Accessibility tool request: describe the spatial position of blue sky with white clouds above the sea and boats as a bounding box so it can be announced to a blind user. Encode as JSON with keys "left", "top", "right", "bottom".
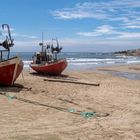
{"left": 0, "top": 0, "right": 140, "bottom": 52}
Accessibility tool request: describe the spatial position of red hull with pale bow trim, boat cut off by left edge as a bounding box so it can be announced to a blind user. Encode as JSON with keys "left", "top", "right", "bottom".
{"left": 0, "top": 57, "right": 23, "bottom": 86}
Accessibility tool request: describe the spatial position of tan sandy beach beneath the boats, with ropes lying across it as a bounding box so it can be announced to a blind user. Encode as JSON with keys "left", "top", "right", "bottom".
{"left": 0, "top": 65, "right": 140, "bottom": 140}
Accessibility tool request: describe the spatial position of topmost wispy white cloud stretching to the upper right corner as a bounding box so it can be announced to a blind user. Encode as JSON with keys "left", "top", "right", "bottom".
{"left": 52, "top": 0, "right": 140, "bottom": 22}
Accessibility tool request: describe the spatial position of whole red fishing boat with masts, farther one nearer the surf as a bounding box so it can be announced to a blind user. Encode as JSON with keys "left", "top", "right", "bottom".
{"left": 30, "top": 34, "right": 67, "bottom": 75}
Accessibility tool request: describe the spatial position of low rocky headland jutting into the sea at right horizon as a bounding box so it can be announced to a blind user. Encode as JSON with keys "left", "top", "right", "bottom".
{"left": 114, "top": 49, "right": 140, "bottom": 56}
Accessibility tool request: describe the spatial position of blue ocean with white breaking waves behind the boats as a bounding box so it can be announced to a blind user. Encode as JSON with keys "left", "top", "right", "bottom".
{"left": 10, "top": 52, "right": 140, "bottom": 70}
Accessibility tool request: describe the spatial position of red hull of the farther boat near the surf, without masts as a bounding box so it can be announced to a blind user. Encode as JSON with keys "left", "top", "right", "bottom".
{"left": 30, "top": 59, "right": 67, "bottom": 75}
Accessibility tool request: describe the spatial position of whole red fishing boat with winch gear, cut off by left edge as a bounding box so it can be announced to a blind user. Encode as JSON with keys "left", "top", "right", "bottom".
{"left": 0, "top": 24, "right": 23, "bottom": 86}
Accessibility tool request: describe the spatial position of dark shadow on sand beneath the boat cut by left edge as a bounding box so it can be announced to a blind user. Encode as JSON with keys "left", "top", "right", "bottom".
{"left": 0, "top": 84, "right": 24, "bottom": 93}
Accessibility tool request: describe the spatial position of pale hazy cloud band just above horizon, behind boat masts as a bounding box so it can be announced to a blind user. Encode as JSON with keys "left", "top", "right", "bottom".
{"left": 12, "top": 35, "right": 140, "bottom": 52}
